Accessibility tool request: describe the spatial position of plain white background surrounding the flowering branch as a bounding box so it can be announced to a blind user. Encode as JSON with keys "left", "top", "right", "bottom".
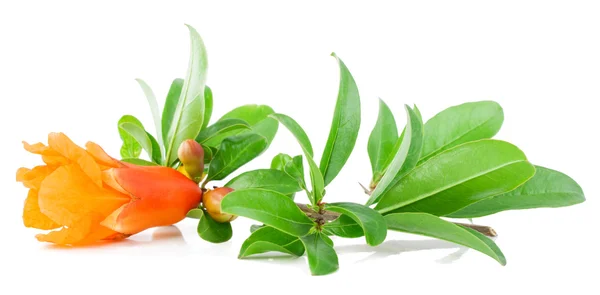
{"left": 0, "top": 0, "right": 600, "bottom": 294}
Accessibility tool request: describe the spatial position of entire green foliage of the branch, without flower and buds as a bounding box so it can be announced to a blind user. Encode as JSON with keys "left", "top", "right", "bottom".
{"left": 119, "top": 27, "right": 585, "bottom": 275}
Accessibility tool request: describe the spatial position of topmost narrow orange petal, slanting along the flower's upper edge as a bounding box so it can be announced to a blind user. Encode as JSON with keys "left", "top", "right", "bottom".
{"left": 48, "top": 133, "right": 102, "bottom": 186}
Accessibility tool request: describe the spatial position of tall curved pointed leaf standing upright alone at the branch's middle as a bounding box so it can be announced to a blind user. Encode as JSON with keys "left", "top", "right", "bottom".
{"left": 319, "top": 53, "right": 360, "bottom": 186}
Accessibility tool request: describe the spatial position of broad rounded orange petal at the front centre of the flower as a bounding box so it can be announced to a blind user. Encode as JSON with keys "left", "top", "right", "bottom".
{"left": 38, "top": 164, "right": 131, "bottom": 227}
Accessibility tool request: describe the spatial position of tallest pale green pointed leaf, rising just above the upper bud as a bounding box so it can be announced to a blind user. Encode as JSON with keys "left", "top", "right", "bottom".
{"left": 166, "top": 25, "right": 208, "bottom": 166}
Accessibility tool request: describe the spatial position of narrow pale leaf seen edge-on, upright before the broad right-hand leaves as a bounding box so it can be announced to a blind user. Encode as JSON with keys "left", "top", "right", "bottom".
{"left": 367, "top": 105, "right": 423, "bottom": 205}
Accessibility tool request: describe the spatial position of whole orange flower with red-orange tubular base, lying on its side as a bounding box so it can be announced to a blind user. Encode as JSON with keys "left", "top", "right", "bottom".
{"left": 17, "top": 133, "right": 202, "bottom": 245}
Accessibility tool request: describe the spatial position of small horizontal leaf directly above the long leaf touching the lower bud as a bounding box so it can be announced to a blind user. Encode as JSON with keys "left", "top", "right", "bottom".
{"left": 225, "top": 169, "right": 302, "bottom": 195}
